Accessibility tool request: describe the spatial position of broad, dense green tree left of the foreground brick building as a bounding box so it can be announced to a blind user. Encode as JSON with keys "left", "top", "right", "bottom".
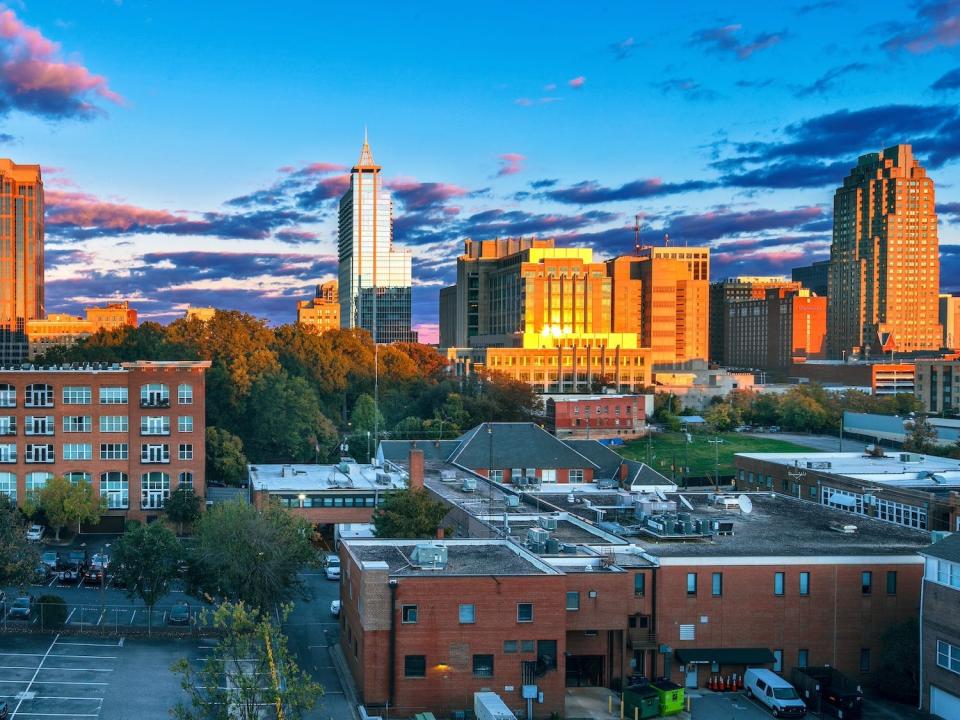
{"left": 191, "top": 501, "right": 316, "bottom": 610}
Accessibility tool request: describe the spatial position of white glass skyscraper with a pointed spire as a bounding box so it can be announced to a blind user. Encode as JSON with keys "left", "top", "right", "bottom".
{"left": 338, "top": 136, "right": 416, "bottom": 343}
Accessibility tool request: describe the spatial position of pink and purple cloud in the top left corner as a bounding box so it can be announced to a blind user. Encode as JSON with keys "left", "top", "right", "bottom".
{"left": 0, "top": 6, "right": 124, "bottom": 120}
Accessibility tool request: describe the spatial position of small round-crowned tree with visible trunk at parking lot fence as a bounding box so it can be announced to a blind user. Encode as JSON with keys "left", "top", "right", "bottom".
{"left": 110, "top": 522, "right": 181, "bottom": 632}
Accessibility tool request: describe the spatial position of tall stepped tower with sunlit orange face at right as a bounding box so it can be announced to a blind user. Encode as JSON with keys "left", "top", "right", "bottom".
{"left": 828, "top": 145, "right": 943, "bottom": 357}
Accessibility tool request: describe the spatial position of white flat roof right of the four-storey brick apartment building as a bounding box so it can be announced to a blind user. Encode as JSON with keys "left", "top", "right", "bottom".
{"left": 247, "top": 462, "right": 407, "bottom": 493}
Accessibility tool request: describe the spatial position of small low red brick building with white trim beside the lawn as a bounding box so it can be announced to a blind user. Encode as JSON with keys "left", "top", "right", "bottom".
{"left": 546, "top": 395, "right": 653, "bottom": 440}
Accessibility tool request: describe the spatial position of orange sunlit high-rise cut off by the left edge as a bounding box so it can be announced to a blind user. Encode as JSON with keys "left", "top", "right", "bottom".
{"left": 0, "top": 158, "right": 45, "bottom": 365}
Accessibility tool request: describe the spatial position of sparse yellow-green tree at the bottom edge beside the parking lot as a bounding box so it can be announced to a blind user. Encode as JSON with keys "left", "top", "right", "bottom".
{"left": 172, "top": 603, "right": 323, "bottom": 720}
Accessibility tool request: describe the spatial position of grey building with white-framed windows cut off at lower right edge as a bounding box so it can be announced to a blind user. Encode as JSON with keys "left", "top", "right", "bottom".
{"left": 920, "top": 534, "right": 960, "bottom": 720}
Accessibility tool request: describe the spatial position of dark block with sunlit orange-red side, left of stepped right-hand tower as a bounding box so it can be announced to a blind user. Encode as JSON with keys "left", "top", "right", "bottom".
{"left": 723, "top": 288, "right": 827, "bottom": 379}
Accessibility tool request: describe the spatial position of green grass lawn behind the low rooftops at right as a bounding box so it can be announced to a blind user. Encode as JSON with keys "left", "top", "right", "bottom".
{"left": 615, "top": 432, "right": 810, "bottom": 480}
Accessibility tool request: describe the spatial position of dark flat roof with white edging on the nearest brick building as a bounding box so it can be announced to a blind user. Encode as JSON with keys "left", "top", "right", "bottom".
{"left": 343, "top": 539, "right": 560, "bottom": 577}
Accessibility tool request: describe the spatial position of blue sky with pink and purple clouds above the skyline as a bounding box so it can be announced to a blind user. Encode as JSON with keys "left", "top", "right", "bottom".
{"left": 0, "top": 0, "right": 960, "bottom": 341}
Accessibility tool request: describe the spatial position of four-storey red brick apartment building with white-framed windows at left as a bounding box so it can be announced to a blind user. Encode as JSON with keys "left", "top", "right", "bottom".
{"left": 0, "top": 361, "right": 210, "bottom": 532}
